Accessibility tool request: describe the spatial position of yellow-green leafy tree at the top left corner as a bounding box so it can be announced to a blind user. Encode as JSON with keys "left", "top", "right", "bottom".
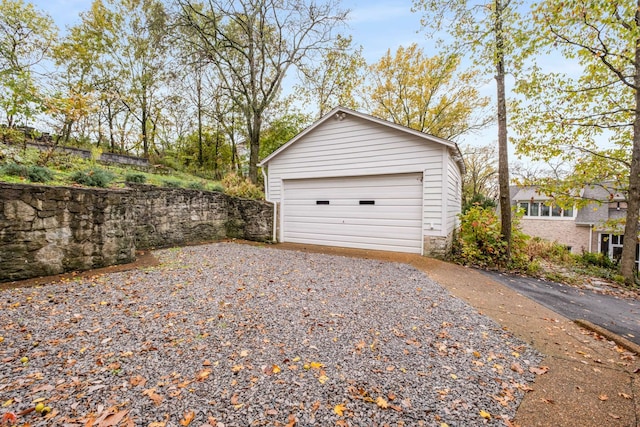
{"left": 0, "top": 0, "right": 58, "bottom": 127}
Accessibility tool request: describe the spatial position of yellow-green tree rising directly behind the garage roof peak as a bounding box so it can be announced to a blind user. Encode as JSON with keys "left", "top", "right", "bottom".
{"left": 296, "top": 35, "right": 367, "bottom": 118}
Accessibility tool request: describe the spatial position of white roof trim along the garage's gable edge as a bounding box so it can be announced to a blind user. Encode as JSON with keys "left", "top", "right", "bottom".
{"left": 258, "top": 106, "right": 465, "bottom": 173}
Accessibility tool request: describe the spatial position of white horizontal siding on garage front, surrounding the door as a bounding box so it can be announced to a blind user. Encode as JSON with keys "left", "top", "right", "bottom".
{"left": 268, "top": 115, "right": 443, "bottom": 234}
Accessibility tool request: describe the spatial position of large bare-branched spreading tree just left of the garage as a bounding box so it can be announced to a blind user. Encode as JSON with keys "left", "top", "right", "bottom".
{"left": 176, "top": 0, "right": 346, "bottom": 183}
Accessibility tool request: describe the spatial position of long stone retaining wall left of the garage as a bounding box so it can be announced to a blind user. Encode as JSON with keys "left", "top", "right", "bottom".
{"left": 0, "top": 183, "right": 273, "bottom": 282}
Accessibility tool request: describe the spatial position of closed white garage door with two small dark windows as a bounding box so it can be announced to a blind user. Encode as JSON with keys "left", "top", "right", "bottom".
{"left": 282, "top": 173, "right": 422, "bottom": 253}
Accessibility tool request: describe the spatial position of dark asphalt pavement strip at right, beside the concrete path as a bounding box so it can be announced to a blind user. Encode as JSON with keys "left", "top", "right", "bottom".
{"left": 480, "top": 270, "right": 640, "bottom": 345}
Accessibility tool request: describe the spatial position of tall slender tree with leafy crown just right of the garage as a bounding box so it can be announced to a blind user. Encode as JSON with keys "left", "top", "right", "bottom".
{"left": 413, "top": 0, "right": 526, "bottom": 259}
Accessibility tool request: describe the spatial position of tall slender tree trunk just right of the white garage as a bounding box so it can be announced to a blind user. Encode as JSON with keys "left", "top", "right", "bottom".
{"left": 495, "top": 0, "right": 511, "bottom": 261}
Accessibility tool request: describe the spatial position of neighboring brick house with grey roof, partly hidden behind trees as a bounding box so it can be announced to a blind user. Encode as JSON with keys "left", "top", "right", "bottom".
{"left": 511, "top": 186, "right": 638, "bottom": 263}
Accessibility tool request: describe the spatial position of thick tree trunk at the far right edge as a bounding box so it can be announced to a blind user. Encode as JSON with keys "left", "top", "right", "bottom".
{"left": 620, "top": 21, "right": 640, "bottom": 285}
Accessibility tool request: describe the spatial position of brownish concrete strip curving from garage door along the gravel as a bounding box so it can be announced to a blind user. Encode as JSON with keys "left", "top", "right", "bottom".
{"left": 275, "top": 243, "right": 640, "bottom": 427}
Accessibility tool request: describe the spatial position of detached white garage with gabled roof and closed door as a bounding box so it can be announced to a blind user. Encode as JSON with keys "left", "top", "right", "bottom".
{"left": 259, "top": 107, "right": 464, "bottom": 255}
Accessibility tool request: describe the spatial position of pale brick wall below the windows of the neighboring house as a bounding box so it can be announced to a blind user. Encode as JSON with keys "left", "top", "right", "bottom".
{"left": 520, "top": 218, "right": 598, "bottom": 254}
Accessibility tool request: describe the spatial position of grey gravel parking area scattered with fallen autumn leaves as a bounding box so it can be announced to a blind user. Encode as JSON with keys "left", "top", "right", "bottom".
{"left": 0, "top": 243, "right": 544, "bottom": 427}
